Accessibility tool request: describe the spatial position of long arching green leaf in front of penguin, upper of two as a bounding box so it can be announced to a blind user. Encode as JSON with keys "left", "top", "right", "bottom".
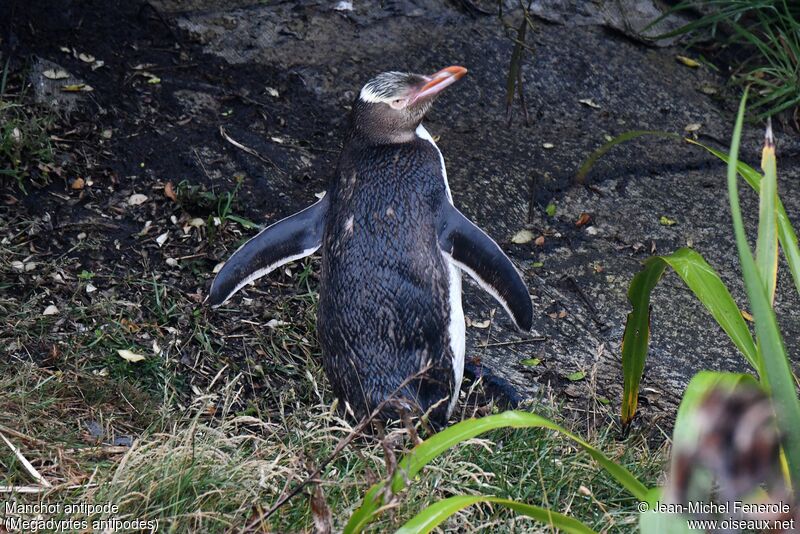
{"left": 344, "top": 410, "right": 648, "bottom": 534}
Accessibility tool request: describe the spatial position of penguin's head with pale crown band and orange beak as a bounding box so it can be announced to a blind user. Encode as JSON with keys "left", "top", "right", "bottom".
{"left": 352, "top": 66, "right": 467, "bottom": 144}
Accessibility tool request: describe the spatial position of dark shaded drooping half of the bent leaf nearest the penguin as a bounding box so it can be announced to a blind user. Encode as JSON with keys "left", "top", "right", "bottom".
{"left": 621, "top": 257, "right": 667, "bottom": 425}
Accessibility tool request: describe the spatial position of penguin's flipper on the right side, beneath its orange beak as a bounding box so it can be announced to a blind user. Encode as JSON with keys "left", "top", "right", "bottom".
{"left": 439, "top": 202, "right": 533, "bottom": 332}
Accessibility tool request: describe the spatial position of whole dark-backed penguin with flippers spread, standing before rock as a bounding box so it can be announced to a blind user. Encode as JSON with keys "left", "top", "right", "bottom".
{"left": 208, "top": 66, "right": 533, "bottom": 428}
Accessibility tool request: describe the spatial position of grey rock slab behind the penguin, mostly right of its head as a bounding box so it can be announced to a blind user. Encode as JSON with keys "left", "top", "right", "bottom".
{"left": 147, "top": 0, "right": 800, "bottom": 426}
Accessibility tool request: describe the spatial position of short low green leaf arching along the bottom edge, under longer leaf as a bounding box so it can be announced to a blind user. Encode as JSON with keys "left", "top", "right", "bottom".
{"left": 396, "top": 495, "right": 595, "bottom": 534}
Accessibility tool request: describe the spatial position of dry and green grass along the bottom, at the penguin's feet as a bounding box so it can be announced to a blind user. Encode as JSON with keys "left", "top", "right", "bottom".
{"left": 0, "top": 354, "right": 665, "bottom": 532}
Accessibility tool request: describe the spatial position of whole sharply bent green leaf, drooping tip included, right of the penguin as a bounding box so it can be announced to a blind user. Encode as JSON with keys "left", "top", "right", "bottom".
{"left": 621, "top": 248, "right": 761, "bottom": 425}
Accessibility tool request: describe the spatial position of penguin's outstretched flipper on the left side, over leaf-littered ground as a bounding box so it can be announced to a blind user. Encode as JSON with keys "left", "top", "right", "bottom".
{"left": 208, "top": 195, "right": 330, "bottom": 308}
